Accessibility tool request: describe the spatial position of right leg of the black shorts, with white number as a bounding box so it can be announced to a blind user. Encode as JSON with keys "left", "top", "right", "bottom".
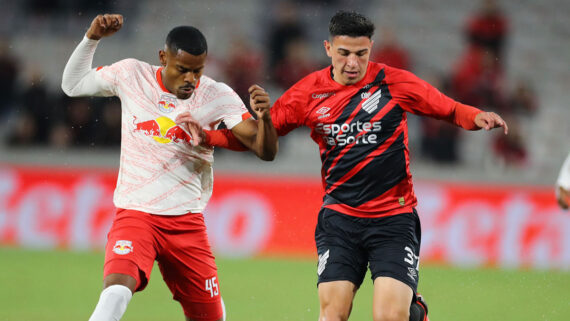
{"left": 363, "top": 211, "right": 421, "bottom": 292}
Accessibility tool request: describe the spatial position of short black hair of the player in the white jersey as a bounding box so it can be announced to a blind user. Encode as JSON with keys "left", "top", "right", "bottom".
{"left": 166, "top": 26, "right": 208, "bottom": 56}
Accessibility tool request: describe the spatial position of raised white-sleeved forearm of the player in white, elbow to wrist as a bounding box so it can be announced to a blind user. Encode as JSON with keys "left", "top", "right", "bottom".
{"left": 61, "top": 37, "right": 98, "bottom": 97}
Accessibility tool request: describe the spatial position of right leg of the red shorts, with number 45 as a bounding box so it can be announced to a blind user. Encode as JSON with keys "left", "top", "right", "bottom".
{"left": 157, "top": 214, "right": 223, "bottom": 320}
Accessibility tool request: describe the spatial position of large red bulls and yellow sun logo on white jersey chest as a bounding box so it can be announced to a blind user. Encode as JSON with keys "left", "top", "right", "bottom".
{"left": 134, "top": 116, "right": 192, "bottom": 144}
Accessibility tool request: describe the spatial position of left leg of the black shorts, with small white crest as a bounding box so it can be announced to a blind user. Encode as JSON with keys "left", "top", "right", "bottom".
{"left": 315, "top": 208, "right": 368, "bottom": 288}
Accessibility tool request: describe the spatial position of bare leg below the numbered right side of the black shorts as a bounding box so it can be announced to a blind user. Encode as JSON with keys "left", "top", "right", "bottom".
{"left": 372, "top": 277, "right": 414, "bottom": 321}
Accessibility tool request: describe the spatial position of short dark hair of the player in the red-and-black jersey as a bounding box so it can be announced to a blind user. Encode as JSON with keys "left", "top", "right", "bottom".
{"left": 329, "top": 10, "right": 375, "bottom": 39}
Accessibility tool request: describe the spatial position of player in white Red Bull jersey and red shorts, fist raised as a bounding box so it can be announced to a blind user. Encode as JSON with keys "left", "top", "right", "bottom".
{"left": 62, "top": 14, "right": 278, "bottom": 321}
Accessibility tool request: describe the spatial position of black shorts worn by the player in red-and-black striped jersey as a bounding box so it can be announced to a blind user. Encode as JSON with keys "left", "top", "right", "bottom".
{"left": 315, "top": 208, "right": 421, "bottom": 293}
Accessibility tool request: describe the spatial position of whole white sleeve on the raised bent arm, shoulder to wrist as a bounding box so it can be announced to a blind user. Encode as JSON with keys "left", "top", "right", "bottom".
{"left": 61, "top": 37, "right": 124, "bottom": 97}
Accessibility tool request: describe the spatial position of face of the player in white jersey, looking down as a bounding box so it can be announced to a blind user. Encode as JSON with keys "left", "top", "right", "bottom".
{"left": 159, "top": 49, "right": 207, "bottom": 99}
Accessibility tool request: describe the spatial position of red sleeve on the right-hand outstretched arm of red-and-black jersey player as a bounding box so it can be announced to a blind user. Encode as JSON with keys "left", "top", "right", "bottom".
{"left": 391, "top": 68, "right": 482, "bottom": 130}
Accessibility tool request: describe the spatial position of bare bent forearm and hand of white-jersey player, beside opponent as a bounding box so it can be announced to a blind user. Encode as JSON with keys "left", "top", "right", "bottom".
{"left": 227, "top": 85, "right": 279, "bottom": 161}
